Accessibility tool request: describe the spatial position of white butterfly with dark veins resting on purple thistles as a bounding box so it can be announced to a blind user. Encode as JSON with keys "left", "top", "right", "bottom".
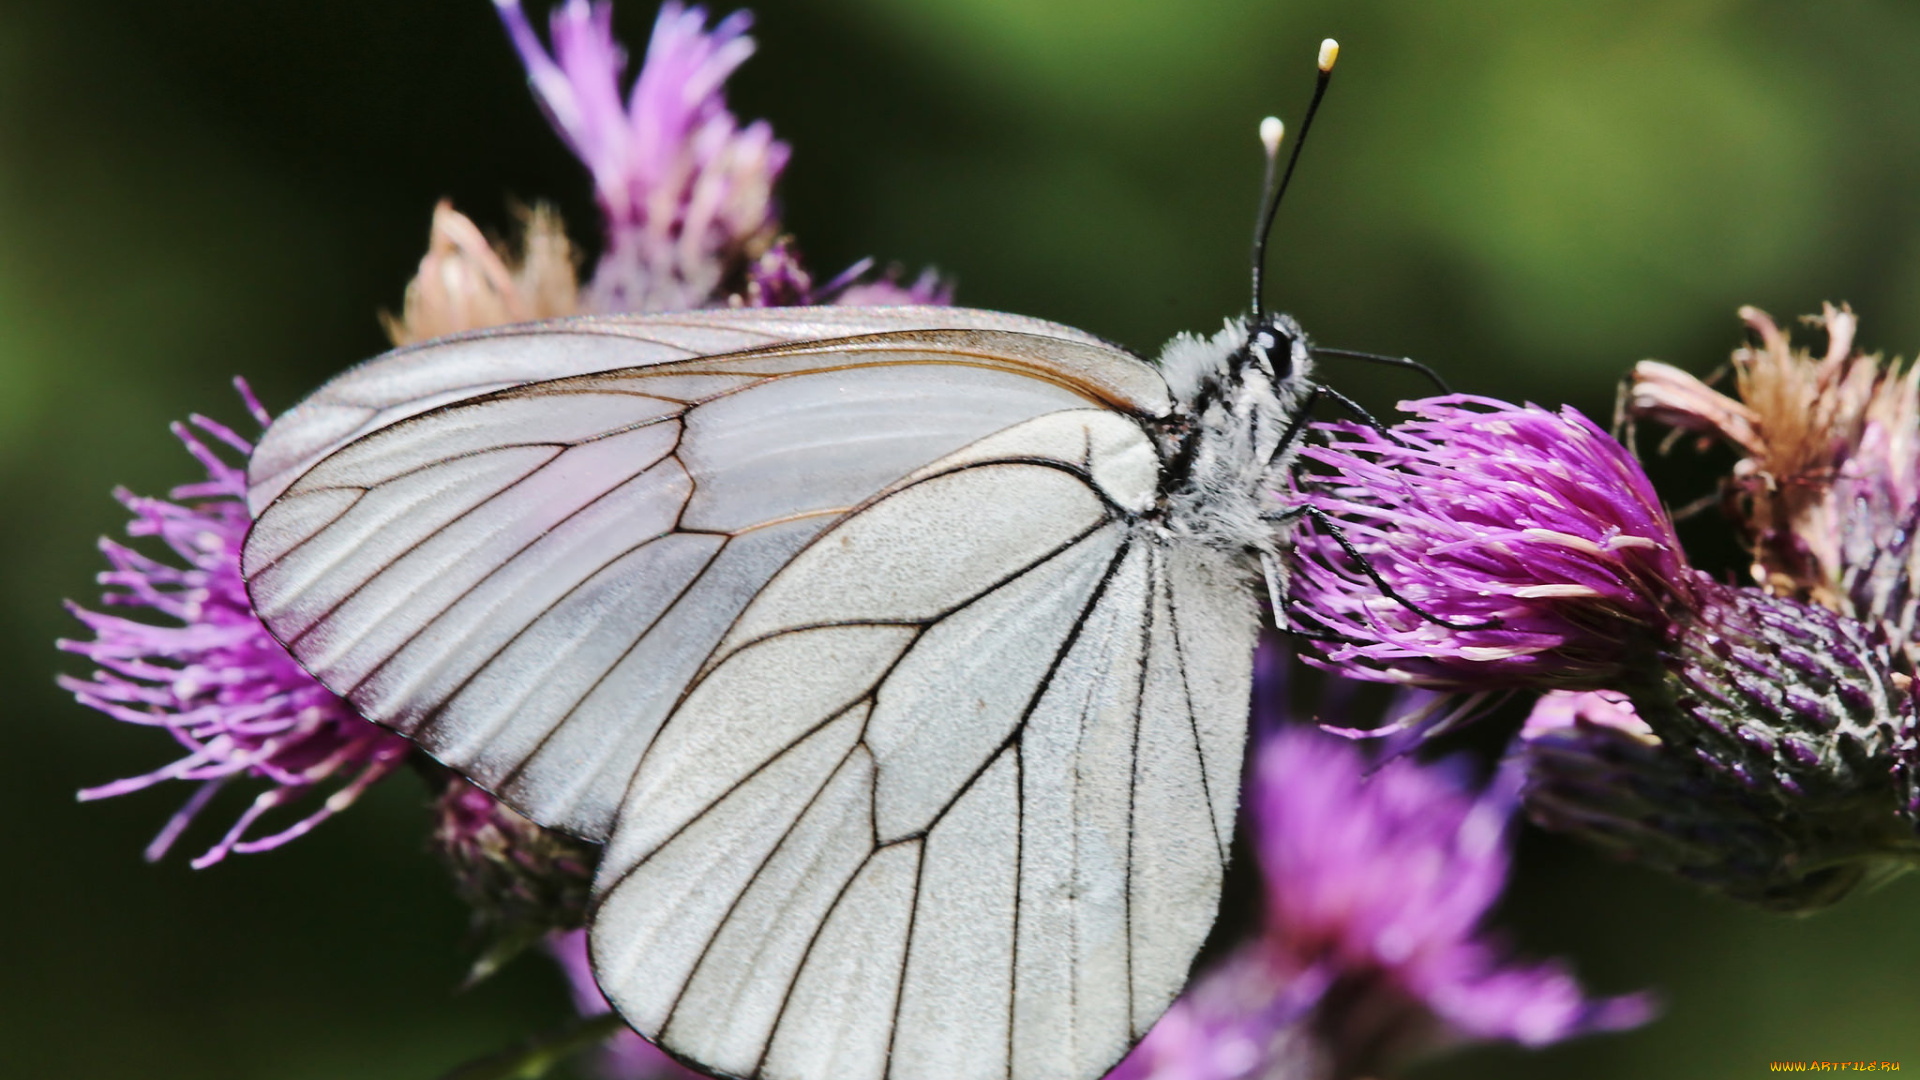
{"left": 244, "top": 37, "right": 1443, "bottom": 1080}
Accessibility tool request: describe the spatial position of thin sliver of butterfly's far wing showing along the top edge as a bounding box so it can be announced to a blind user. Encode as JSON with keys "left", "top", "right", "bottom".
{"left": 248, "top": 306, "right": 1136, "bottom": 515}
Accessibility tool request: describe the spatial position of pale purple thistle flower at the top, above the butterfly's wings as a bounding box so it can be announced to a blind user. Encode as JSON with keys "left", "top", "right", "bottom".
{"left": 495, "top": 0, "right": 789, "bottom": 311}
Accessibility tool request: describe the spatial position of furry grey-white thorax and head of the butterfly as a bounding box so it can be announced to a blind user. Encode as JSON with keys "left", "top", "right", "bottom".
{"left": 1160, "top": 315, "right": 1313, "bottom": 557}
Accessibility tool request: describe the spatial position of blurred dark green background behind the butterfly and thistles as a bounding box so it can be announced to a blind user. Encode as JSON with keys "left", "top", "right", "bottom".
{"left": 11, "top": 0, "right": 1920, "bottom": 1080}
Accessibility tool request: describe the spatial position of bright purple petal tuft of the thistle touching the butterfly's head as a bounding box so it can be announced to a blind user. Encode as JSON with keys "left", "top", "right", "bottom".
{"left": 1292, "top": 394, "right": 1695, "bottom": 688}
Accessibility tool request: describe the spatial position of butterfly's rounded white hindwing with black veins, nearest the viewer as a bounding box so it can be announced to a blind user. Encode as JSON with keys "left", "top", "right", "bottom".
{"left": 593, "top": 409, "right": 1252, "bottom": 1078}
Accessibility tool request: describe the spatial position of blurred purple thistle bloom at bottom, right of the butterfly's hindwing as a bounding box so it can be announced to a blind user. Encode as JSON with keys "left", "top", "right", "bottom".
{"left": 1114, "top": 714, "right": 1651, "bottom": 1080}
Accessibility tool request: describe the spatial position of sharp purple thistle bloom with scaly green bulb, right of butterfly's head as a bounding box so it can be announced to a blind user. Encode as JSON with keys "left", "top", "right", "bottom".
{"left": 1294, "top": 390, "right": 1920, "bottom": 909}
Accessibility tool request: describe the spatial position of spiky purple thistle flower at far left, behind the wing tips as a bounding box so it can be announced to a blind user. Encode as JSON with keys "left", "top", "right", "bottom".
{"left": 60, "top": 380, "right": 411, "bottom": 869}
